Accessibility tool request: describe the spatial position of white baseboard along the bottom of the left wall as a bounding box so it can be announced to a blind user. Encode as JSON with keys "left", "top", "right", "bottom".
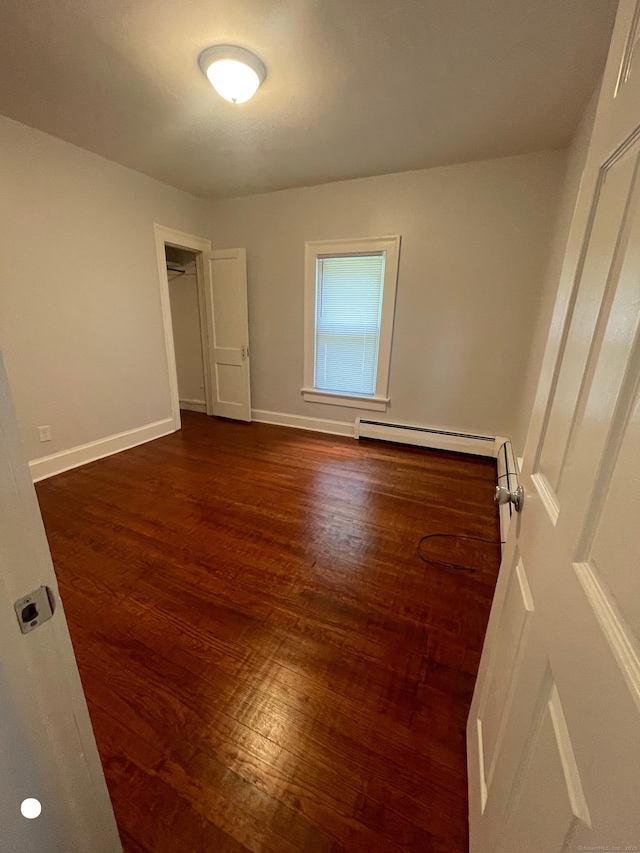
{"left": 29, "top": 418, "right": 175, "bottom": 483}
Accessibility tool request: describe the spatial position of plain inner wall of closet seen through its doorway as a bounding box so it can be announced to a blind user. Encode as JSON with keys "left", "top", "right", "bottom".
{"left": 169, "top": 261, "right": 205, "bottom": 404}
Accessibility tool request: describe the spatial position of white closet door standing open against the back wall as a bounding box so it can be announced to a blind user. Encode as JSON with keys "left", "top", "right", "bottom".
{"left": 205, "top": 249, "right": 251, "bottom": 421}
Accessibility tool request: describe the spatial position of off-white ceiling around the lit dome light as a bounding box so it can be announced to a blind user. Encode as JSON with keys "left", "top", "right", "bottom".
{"left": 0, "top": 0, "right": 615, "bottom": 197}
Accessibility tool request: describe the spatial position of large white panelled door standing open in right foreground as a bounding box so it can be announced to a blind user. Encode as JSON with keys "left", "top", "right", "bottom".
{"left": 467, "top": 0, "right": 640, "bottom": 853}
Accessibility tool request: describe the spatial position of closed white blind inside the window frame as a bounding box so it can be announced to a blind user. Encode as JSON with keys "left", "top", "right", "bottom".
{"left": 314, "top": 252, "right": 386, "bottom": 395}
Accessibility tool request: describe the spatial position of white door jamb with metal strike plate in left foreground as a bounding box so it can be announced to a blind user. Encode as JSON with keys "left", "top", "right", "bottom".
{"left": 0, "top": 350, "right": 122, "bottom": 853}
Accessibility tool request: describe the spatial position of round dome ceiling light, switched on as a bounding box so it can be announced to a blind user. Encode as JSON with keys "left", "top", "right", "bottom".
{"left": 198, "top": 44, "right": 267, "bottom": 104}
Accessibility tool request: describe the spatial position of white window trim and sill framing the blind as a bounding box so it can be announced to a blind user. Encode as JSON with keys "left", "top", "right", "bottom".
{"left": 300, "top": 235, "right": 400, "bottom": 412}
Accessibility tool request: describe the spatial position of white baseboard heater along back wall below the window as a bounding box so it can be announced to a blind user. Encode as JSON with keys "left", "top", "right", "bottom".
{"left": 354, "top": 418, "right": 497, "bottom": 457}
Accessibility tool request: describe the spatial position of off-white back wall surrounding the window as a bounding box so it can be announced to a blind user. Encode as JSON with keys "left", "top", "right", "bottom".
{"left": 209, "top": 152, "right": 564, "bottom": 435}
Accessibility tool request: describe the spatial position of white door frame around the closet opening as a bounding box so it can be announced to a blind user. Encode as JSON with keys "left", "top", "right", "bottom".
{"left": 153, "top": 223, "right": 214, "bottom": 430}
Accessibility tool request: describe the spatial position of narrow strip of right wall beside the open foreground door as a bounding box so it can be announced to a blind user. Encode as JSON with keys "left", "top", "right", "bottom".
{"left": 513, "top": 86, "right": 600, "bottom": 455}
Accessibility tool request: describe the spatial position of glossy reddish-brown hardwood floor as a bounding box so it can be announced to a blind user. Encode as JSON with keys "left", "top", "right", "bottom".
{"left": 37, "top": 412, "right": 499, "bottom": 853}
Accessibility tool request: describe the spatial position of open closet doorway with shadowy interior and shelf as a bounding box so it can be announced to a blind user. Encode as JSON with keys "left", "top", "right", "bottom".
{"left": 165, "top": 244, "right": 207, "bottom": 413}
